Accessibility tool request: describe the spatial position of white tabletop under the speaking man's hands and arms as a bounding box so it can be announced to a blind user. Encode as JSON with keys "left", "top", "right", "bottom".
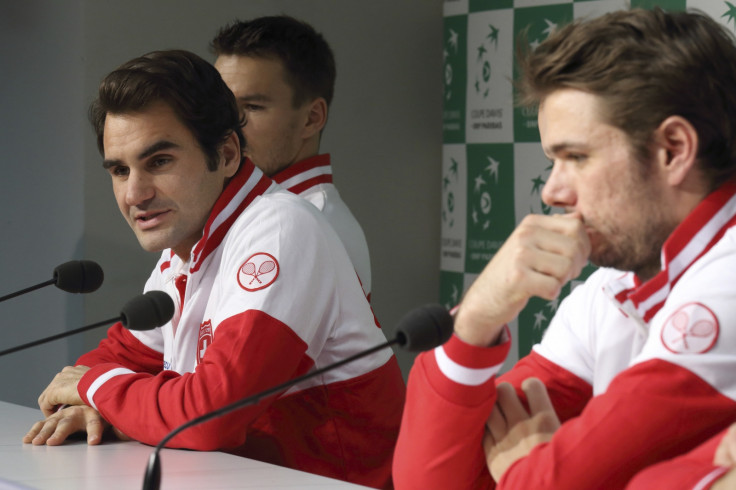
{"left": 0, "top": 402, "right": 366, "bottom": 490}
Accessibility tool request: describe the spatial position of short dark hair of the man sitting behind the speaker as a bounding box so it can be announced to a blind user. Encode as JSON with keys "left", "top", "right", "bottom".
{"left": 211, "top": 15, "right": 336, "bottom": 107}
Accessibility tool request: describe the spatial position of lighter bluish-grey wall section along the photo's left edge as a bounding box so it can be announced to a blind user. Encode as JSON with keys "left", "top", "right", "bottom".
{"left": 0, "top": 0, "right": 88, "bottom": 405}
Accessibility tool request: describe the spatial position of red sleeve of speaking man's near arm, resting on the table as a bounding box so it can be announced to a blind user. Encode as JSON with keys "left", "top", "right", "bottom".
{"left": 78, "top": 310, "right": 312, "bottom": 450}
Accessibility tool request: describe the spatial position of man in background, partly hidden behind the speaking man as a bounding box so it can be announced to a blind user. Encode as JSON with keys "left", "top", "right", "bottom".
{"left": 211, "top": 15, "right": 371, "bottom": 300}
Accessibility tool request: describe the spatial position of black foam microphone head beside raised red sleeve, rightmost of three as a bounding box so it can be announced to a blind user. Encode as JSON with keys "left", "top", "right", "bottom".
{"left": 396, "top": 304, "right": 453, "bottom": 352}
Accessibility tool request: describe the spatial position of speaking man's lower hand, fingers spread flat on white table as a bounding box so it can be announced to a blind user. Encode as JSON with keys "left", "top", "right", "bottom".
{"left": 23, "top": 405, "right": 110, "bottom": 446}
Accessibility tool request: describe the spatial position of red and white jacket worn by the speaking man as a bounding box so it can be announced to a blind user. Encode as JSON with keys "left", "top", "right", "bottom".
{"left": 77, "top": 162, "right": 405, "bottom": 487}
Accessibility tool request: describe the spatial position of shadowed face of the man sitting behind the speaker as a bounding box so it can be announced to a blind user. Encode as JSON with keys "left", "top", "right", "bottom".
{"left": 215, "top": 55, "right": 312, "bottom": 176}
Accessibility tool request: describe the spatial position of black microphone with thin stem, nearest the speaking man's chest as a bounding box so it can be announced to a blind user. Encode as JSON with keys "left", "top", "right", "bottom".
{"left": 0, "top": 291, "right": 174, "bottom": 356}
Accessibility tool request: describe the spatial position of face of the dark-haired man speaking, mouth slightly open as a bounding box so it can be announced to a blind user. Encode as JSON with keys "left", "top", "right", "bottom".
{"left": 103, "top": 103, "right": 237, "bottom": 260}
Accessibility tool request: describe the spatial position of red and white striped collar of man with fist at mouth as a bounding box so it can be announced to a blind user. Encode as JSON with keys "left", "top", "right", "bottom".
{"left": 606, "top": 182, "right": 736, "bottom": 323}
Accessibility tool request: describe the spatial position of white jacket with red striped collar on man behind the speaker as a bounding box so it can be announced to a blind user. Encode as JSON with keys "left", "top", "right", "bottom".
{"left": 273, "top": 154, "right": 371, "bottom": 301}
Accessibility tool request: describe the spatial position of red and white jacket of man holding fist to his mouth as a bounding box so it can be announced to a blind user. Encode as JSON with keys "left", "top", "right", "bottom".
{"left": 394, "top": 184, "right": 736, "bottom": 490}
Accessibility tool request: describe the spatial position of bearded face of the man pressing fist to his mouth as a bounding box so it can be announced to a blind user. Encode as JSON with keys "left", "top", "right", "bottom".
{"left": 539, "top": 89, "right": 677, "bottom": 279}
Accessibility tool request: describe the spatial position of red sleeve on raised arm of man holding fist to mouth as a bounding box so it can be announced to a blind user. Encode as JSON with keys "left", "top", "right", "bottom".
{"left": 394, "top": 336, "right": 592, "bottom": 489}
